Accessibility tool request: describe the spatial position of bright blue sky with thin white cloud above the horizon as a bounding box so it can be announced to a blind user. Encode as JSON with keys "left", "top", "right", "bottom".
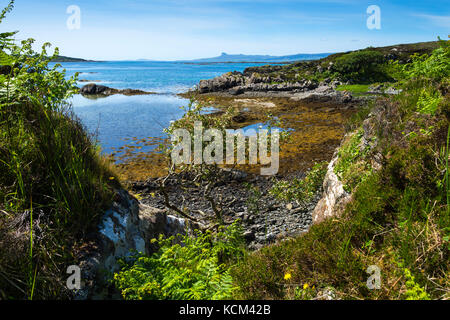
{"left": 0, "top": 0, "right": 450, "bottom": 61}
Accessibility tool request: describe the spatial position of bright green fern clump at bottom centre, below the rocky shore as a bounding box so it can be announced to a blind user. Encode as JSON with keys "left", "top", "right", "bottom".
{"left": 114, "top": 223, "right": 244, "bottom": 300}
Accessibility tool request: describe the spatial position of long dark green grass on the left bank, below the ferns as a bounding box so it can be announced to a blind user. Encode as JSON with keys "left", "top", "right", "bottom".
{"left": 0, "top": 104, "right": 119, "bottom": 297}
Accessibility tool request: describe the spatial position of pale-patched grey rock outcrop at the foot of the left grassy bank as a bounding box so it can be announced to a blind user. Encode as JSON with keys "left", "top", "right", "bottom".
{"left": 74, "top": 190, "right": 189, "bottom": 300}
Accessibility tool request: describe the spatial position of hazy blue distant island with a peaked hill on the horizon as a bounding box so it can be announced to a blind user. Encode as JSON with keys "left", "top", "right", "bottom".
{"left": 182, "top": 52, "right": 332, "bottom": 63}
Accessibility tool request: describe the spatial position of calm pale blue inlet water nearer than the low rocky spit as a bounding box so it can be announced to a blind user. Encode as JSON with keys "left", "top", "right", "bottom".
{"left": 72, "top": 95, "right": 188, "bottom": 154}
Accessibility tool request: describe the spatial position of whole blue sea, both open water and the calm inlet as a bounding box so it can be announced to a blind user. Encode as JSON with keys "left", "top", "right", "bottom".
{"left": 52, "top": 61, "right": 276, "bottom": 154}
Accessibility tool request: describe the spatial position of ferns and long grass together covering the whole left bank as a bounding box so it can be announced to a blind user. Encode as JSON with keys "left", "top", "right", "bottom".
{"left": 0, "top": 1, "right": 119, "bottom": 299}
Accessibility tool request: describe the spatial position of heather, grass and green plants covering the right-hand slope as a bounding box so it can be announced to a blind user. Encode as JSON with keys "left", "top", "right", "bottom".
{"left": 231, "top": 41, "right": 450, "bottom": 299}
